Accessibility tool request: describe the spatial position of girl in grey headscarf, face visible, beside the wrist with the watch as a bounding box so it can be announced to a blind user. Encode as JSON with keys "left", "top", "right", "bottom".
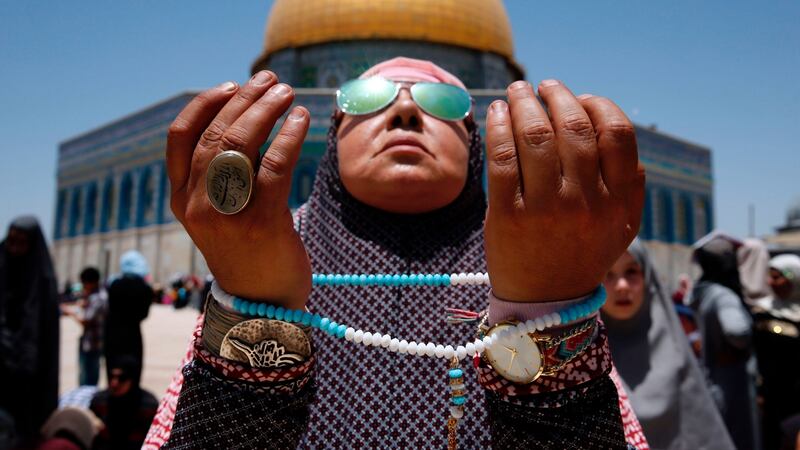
{"left": 602, "top": 243, "right": 733, "bottom": 449}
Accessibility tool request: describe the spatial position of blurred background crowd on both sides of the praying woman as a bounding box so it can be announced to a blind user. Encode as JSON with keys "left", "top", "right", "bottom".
{"left": 0, "top": 213, "right": 800, "bottom": 450}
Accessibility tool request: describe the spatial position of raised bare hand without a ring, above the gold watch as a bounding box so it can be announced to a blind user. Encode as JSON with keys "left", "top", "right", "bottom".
{"left": 484, "top": 80, "right": 645, "bottom": 301}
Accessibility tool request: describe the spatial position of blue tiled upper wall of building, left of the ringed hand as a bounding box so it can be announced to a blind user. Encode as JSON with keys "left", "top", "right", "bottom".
{"left": 53, "top": 93, "right": 194, "bottom": 240}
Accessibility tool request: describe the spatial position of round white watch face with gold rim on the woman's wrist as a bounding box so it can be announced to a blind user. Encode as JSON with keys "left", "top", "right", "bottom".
{"left": 484, "top": 324, "right": 542, "bottom": 384}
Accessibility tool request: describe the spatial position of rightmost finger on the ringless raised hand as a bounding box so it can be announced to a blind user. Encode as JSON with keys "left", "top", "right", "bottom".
{"left": 580, "top": 95, "right": 639, "bottom": 196}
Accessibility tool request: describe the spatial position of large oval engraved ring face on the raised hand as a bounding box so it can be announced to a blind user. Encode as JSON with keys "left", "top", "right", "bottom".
{"left": 206, "top": 150, "right": 253, "bottom": 214}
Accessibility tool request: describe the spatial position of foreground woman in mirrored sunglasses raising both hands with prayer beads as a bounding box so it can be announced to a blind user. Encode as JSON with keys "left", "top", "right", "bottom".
{"left": 148, "top": 58, "right": 646, "bottom": 448}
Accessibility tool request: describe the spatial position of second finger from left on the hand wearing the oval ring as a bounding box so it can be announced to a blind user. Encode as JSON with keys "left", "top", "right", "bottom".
{"left": 194, "top": 70, "right": 278, "bottom": 163}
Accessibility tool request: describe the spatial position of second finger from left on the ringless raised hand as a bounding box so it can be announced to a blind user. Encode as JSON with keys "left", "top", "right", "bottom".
{"left": 507, "top": 81, "right": 561, "bottom": 202}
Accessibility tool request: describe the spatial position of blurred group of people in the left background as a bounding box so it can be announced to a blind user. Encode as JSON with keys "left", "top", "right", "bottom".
{"left": 0, "top": 216, "right": 205, "bottom": 450}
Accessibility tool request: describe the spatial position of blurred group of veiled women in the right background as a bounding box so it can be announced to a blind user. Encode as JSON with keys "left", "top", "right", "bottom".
{"left": 602, "top": 233, "right": 800, "bottom": 449}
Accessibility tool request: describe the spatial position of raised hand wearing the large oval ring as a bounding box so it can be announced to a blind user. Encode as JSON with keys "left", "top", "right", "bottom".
{"left": 167, "top": 71, "right": 311, "bottom": 309}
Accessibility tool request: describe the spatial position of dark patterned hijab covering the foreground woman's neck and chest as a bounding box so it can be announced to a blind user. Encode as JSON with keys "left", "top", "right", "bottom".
{"left": 297, "top": 61, "right": 490, "bottom": 448}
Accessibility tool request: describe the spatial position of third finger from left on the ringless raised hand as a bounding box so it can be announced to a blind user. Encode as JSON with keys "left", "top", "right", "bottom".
{"left": 539, "top": 80, "right": 599, "bottom": 192}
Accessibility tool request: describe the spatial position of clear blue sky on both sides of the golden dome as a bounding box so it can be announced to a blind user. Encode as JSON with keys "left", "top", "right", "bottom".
{"left": 0, "top": 0, "right": 800, "bottom": 238}
